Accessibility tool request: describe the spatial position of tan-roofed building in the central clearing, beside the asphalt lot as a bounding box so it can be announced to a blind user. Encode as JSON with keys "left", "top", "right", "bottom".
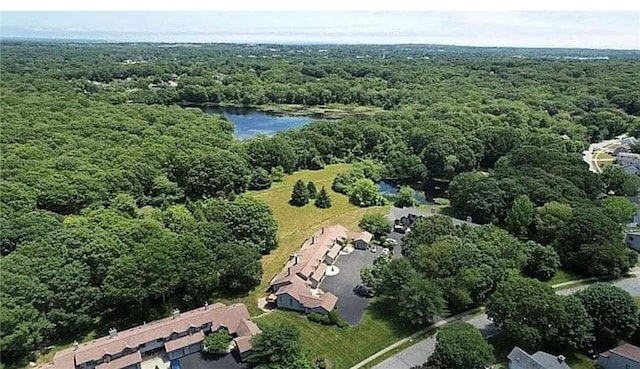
{"left": 267, "top": 225, "right": 373, "bottom": 314}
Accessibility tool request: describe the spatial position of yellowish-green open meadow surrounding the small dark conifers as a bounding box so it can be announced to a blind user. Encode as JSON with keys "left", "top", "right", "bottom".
{"left": 228, "top": 164, "right": 390, "bottom": 315}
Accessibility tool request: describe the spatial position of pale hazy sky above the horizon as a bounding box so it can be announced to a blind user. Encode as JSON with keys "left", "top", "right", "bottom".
{"left": 0, "top": 12, "right": 640, "bottom": 49}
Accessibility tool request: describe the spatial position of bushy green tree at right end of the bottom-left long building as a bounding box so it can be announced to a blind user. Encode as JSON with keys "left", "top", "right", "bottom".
{"left": 247, "top": 324, "right": 312, "bottom": 369}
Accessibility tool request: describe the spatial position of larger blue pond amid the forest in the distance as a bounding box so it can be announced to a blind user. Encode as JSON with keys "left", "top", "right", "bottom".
{"left": 202, "top": 107, "right": 313, "bottom": 139}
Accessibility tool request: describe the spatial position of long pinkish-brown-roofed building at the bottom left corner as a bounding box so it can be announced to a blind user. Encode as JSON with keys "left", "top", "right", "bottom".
{"left": 41, "top": 303, "right": 261, "bottom": 369}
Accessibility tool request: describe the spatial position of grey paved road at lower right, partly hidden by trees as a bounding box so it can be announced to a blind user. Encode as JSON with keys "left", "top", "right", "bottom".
{"left": 364, "top": 271, "right": 640, "bottom": 369}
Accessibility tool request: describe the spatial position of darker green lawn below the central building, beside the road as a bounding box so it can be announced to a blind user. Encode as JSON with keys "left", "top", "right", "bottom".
{"left": 254, "top": 311, "right": 418, "bottom": 369}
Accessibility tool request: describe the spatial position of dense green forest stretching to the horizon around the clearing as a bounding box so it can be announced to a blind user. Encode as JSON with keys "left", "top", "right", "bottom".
{"left": 0, "top": 42, "right": 640, "bottom": 364}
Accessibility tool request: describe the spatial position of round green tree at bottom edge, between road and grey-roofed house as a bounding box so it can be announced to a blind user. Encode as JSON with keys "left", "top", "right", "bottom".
{"left": 426, "top": 322, "right": 495, "bottom": 369}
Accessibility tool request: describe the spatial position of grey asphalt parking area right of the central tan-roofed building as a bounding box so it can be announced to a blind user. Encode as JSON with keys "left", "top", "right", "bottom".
{"left": 320, "top": 247, "right": 382, "bottom": 325}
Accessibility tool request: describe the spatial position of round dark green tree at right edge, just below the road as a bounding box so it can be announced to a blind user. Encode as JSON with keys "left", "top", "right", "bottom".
{"left": 575, "top": 283, "right": 640, "bottom": 339}
